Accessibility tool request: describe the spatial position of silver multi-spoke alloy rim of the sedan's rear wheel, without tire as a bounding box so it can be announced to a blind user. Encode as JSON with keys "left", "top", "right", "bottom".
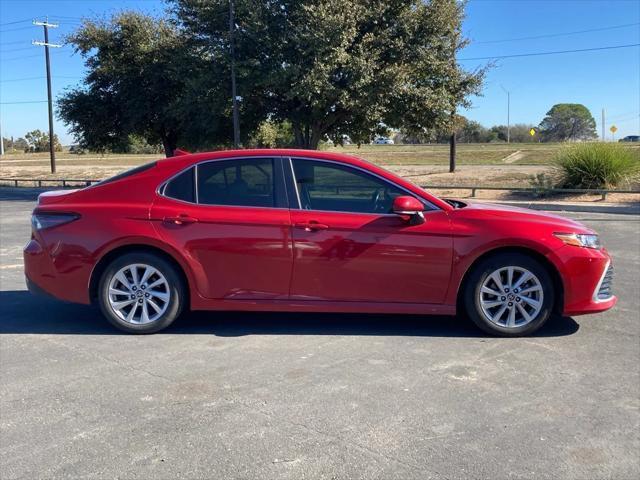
{"left": 108, "top": 263, "right": 171, "bottom": 325}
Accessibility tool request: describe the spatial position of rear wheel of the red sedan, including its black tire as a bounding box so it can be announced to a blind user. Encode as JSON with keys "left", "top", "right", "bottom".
{"left": 98, "top": 252, "right": 186, "bottom": 334}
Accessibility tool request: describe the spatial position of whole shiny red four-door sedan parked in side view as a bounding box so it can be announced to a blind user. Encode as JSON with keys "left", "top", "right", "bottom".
{"left": 24, "top": 150, "right": 616, "bottom": 336}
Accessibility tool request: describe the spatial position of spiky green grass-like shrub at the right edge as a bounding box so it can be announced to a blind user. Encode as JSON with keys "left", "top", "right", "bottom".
{"left": 555, "top": 143, "right": 640, "bottom": 188}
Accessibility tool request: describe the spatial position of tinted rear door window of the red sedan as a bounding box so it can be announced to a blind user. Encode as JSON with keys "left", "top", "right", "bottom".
{"left": 198, "top": 158, "right": 275, "bottom": 207}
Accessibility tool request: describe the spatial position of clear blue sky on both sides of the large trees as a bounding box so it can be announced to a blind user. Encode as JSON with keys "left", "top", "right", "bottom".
{"left": 0, "top": 0, "right": 640, "bottom": 143}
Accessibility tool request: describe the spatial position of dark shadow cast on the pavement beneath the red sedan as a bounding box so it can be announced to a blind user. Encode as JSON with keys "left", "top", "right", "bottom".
{"left": 0, "top": 290, "right": 580, "bottom": 337}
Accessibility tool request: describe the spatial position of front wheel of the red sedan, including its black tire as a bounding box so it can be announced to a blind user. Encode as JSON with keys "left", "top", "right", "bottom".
{"left": 464, "top": 253, "right": 555, "bottom": 337}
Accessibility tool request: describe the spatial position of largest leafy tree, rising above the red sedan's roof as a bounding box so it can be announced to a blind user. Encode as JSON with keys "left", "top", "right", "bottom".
{"left": 171, "top": 0, "right": 484, "bottom": 148}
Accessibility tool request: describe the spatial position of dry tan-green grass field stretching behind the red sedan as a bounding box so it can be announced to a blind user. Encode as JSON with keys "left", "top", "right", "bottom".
{"left": 0, "top": 143, "right": 640, "bottom": 195}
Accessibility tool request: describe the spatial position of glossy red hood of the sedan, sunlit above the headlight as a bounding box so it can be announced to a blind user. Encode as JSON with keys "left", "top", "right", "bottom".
{"left": 459, "top": 202, "right": 595, "bottom": 233}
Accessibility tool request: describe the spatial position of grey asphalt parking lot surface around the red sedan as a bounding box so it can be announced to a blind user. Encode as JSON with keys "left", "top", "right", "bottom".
{"left": 0, "top": 189, "right": 640, "bottom": 479}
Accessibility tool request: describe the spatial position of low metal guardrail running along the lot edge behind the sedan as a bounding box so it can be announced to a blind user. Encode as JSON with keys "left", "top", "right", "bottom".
{"left": 0, "top": 178, "right": 640, "bottom": 200}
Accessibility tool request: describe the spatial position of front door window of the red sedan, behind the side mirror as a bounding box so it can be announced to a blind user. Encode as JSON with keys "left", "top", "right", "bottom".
{"left": 292, "top": 159, "right": 407, "bottom": 213}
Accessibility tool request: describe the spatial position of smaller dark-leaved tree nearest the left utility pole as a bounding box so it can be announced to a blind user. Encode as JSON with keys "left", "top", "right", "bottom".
{"left": 58, "top": 12, "right": 230, "bottom": 156}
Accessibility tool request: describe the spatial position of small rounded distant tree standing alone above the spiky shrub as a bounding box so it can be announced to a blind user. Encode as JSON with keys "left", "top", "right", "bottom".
{"left": 540, "top": 103, "right": 597, "bottom": 142}
